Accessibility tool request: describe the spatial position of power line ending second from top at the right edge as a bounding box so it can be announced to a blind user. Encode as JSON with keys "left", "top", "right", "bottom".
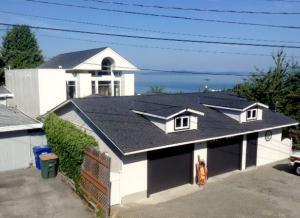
{"left": 83, "top": 0, "right": 300, "bottom": 15}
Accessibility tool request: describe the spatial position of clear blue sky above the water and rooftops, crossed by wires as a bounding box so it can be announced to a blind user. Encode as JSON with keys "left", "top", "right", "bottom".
{"left": 0, "top": 0, "right": 300, "bottom": 90}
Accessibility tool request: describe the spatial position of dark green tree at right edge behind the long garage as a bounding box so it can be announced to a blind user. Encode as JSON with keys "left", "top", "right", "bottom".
{"left": 234, "top": 51, "right": 300, "bottom": 144}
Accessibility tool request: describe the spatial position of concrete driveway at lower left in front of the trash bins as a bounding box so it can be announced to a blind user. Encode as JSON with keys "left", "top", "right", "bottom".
{"left": 0, "top": 169, "right": 93, "bottom": 218}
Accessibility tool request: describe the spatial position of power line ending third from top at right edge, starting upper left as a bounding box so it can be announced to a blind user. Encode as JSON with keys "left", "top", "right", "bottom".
{"left": 24, "top": 0, "right": 300, "bottom": 30}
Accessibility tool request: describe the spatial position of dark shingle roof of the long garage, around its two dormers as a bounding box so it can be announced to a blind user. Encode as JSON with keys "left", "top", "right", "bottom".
{"left": 62, "top": 93, "right": 297, "bottom": 155}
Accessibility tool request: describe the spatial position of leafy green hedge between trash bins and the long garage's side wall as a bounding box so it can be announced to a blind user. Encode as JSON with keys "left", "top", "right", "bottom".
{"left": 44, "top": 113, "right": 97, "bottom": 185}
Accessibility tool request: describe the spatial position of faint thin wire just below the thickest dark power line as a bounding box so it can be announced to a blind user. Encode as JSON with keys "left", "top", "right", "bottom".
{"left": 38, "top": 34, "right": 300, "bottom": 58}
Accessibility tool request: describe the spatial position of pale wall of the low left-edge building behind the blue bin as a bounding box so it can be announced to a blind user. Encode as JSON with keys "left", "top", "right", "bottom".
{"left": 0, "top": 131, "right": 47, "bottom": 171}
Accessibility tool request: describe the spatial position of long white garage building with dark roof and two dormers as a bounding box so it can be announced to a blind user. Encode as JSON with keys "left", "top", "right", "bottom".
{"left": 53, "top": 92, "right": 298, "bottom": 205}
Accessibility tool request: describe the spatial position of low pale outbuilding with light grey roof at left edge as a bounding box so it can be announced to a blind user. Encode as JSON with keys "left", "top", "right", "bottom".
{"left": 0, "top": 105, "right": 46, "bottom": 172}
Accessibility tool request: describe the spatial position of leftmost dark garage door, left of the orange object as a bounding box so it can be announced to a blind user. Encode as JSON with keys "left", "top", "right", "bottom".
{"left": 147, "top": 145, "right": 194, "bottom": 196}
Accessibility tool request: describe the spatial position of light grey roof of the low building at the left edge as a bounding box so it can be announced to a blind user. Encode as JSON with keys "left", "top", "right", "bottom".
{"left": 0, "top": 104, "right": 39, "bottom": 127}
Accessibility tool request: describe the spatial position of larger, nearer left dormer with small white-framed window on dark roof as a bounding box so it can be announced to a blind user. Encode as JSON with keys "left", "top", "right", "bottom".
{"left": 131, "top": 101, "right": 204, "bottom": 134}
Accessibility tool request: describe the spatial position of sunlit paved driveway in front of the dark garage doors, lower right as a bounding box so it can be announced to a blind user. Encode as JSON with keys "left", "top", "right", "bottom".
{"left": 113, "top": 161, "right": 300, "bottom": 217}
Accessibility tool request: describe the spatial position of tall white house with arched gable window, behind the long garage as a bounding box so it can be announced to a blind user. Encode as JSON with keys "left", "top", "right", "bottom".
{"left": 5, "top": 47, "right": 138, "bottom": 117}
